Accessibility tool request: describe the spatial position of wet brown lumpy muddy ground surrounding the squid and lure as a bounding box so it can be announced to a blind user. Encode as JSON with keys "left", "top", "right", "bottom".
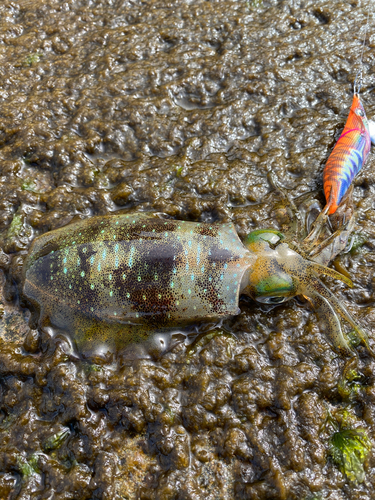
{"left": 0, "top": 0, "right": 375, "bottom": 500}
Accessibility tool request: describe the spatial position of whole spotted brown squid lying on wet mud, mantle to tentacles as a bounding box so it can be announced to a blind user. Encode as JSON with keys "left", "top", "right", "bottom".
{"left": 23, "top": 214, "right": 368, "bottom": 356}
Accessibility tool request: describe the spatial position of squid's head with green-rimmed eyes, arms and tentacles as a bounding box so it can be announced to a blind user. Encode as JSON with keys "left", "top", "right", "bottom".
{"left": 242, "top": 230, "right": 372, "bottom": 356}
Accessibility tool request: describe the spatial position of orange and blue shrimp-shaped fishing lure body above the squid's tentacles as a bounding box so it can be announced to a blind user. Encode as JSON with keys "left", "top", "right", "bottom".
{"left": 323, "top": 94, "right": 375, "bottom": 214}
